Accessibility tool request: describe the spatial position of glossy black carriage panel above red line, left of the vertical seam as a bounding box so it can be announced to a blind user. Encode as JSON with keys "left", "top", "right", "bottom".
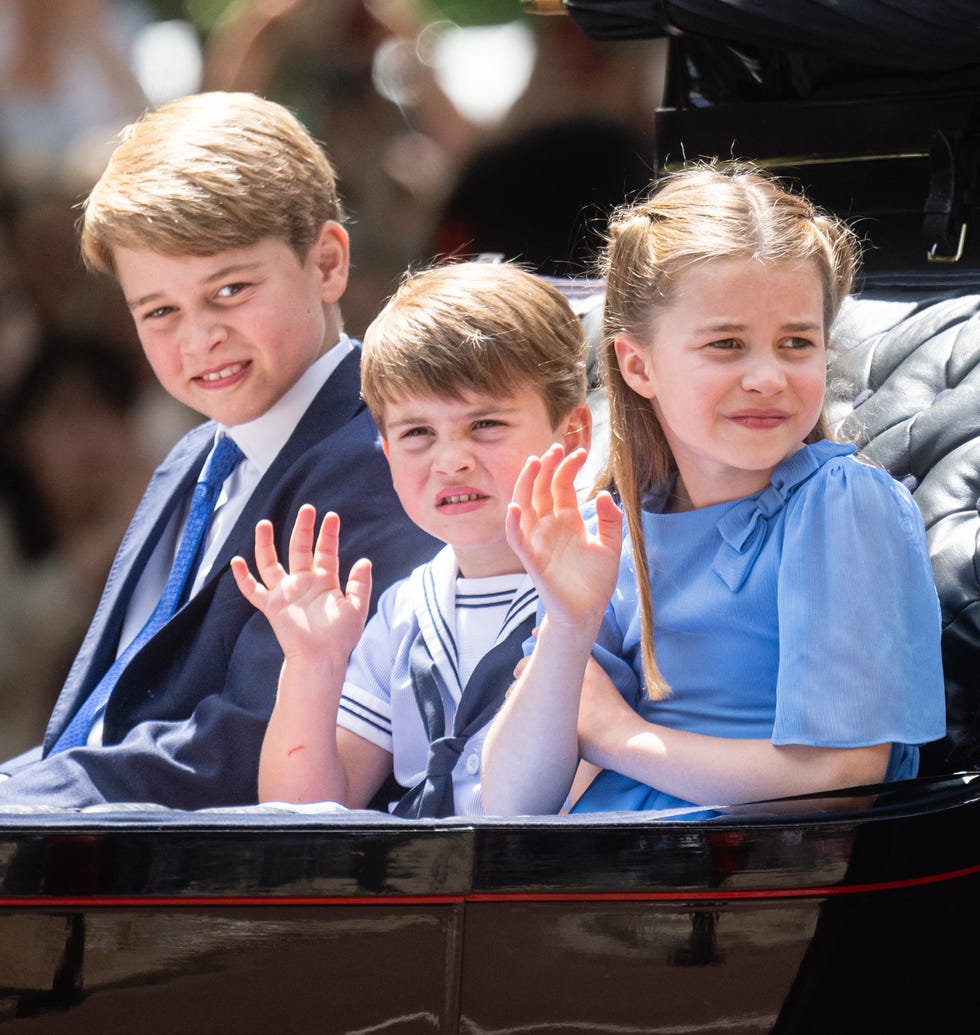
{"left": 0, "top": 824, "right": 472, "bottom": 898}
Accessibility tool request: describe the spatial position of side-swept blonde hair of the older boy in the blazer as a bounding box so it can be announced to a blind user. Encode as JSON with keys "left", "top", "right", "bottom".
{"left": 81, "top": 92, "right": 344, "bottom": 273}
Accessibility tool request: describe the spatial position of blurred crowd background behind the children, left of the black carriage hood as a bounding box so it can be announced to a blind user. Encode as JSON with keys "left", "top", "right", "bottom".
{"left": 0, "top": 0, "right": 664, "bottom": 759}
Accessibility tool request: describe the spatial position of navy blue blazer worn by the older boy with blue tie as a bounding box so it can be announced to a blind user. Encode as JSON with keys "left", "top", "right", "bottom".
{"left": 0, "top": 350, "right": 442, "bottom": 809}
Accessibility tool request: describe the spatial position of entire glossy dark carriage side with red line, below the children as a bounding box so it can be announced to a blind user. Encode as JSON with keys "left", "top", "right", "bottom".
{"left": 0, "top": 779, "right": 980, "bottom": 1035}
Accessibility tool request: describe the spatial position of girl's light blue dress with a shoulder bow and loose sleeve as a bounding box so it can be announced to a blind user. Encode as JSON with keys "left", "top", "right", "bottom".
{"left": 574, "top": 441, "right": 946, "bottom": 812}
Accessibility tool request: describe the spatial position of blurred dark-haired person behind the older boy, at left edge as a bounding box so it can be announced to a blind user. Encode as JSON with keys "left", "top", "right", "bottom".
{"left": 0, "top": 336, "right": 152, "bottom": 758}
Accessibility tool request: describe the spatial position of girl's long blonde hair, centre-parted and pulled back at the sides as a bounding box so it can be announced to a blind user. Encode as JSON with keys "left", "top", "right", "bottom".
{"left": 600, "top": 162, "right": 859, "bottom": 700}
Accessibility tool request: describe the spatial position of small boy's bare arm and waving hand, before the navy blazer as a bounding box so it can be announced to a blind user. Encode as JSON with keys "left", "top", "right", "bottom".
{"left": 232, "top": 505, "right": 391, "bottom": 808}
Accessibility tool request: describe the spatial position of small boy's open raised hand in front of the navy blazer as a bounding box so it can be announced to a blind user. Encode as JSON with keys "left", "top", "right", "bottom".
{"left": 232, "top": 504, "right": 372, "bottom": 663}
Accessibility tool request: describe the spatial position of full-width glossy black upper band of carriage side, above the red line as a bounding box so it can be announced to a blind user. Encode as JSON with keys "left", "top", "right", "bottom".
{"left": 0, "top": 777, "right": 968, "bottom": 899}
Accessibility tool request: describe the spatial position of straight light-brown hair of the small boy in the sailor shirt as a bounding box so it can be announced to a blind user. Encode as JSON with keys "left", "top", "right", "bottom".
{"left": 361, "top": 262, "right": 586, "bottom": 434}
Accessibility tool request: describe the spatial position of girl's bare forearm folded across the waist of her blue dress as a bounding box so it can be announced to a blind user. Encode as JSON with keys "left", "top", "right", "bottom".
{"left": 578, "top": 661, "right": 891, "bottom": 805}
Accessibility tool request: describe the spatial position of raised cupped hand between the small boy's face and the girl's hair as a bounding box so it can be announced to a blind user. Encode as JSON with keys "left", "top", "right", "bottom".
{"left": 507, "top": 445, "right": 622, "bottom": 626}
